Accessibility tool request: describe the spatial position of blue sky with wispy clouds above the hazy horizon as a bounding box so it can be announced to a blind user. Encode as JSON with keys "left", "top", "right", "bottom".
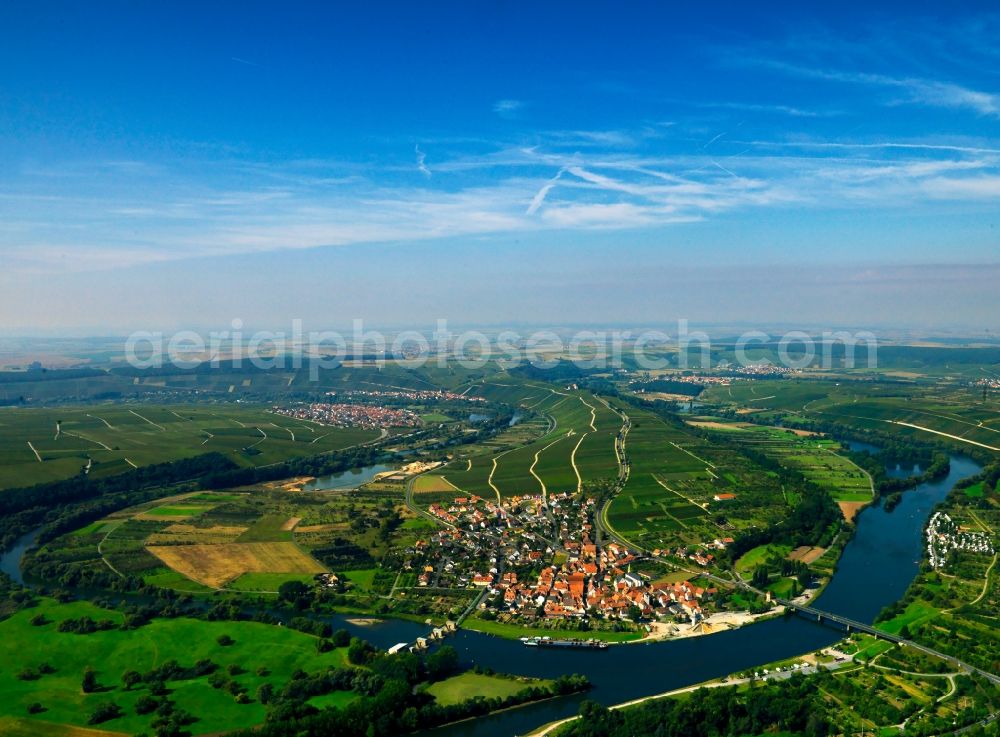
{"left": 0, "top": 2, "right": 1000, "bottom": 333}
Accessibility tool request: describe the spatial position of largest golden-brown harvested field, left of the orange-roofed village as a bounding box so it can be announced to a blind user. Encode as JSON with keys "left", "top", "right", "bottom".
{"left": 146, "top": 542, "right": 325, "bottom": 588}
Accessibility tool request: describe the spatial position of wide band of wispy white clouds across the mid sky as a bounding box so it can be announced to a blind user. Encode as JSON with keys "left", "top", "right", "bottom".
{"left": 0, "top": 122, "right": 1000, "bottom": 273}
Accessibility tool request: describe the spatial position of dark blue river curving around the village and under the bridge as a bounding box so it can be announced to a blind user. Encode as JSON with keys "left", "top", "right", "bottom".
{"left": 0, "top": 456, "right": 980, "bottom": 737}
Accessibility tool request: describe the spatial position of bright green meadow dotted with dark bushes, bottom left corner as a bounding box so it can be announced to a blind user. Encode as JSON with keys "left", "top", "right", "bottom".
{"left": 0, "top": 600, "right": 345, "bottom": 734}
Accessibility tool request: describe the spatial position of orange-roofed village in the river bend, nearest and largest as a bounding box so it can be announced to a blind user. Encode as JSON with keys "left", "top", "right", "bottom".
{"left": 410, "top": 494, "right": 725, "bottom": 627}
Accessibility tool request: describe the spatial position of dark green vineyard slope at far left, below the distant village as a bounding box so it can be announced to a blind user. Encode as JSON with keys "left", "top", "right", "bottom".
{"left": 0, "top": 404, "right": 378, "bottom": 489}
